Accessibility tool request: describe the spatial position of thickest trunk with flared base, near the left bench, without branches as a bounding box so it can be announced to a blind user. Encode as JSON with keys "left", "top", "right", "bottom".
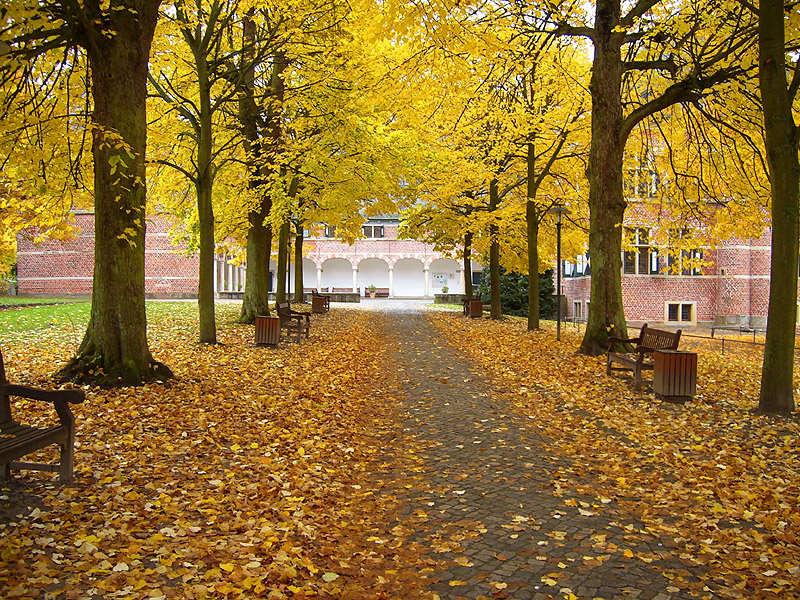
{"left": 58, "top": 0, "right": 172, "bottom": 386}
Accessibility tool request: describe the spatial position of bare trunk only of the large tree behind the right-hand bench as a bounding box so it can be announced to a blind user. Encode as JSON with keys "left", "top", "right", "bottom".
{"left": 580, "top": 0, "right": 627, "bottom": 355}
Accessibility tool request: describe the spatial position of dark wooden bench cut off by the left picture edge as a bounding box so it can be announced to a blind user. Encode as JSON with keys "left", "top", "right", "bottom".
{"left": 0, "top": 353, "right": 86, "bottom": 483}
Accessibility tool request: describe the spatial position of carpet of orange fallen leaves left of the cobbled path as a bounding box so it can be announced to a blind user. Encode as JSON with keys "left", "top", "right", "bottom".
{"left": 0, "top": 304, "right": 438, "bottom": 600}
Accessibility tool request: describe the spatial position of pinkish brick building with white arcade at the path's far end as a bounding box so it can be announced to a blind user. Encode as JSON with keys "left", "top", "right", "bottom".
{"left": 17, "top": 213, "right": 480, "bottom": 298}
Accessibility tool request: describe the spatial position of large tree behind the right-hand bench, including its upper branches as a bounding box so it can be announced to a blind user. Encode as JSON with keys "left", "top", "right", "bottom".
{"left": 554, "top": 0, "right": 753, "bottom": 354}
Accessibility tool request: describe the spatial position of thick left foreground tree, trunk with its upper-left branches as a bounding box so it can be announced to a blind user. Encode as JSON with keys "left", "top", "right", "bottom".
{"left": 0, "top": 0, "right": 171, "bottom": 385}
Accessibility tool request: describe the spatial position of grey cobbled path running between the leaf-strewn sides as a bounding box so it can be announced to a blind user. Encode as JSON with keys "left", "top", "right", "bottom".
{"left": 374, "top": 303, "right": 696, "bottom": 600}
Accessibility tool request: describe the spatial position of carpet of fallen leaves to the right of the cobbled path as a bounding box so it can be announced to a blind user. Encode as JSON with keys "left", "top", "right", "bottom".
{"left": 436, "top": 315, "right": 800, "bottom": 598}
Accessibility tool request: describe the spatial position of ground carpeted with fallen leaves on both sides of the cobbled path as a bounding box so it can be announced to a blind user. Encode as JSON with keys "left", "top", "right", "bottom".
{"left": 0, "top": 306, "right": 800, "bottom": 600}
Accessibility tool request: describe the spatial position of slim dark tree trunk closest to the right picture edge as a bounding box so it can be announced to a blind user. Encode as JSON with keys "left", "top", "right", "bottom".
{"left": 758, "top": 0, "right": 800, "bottom": 415}
